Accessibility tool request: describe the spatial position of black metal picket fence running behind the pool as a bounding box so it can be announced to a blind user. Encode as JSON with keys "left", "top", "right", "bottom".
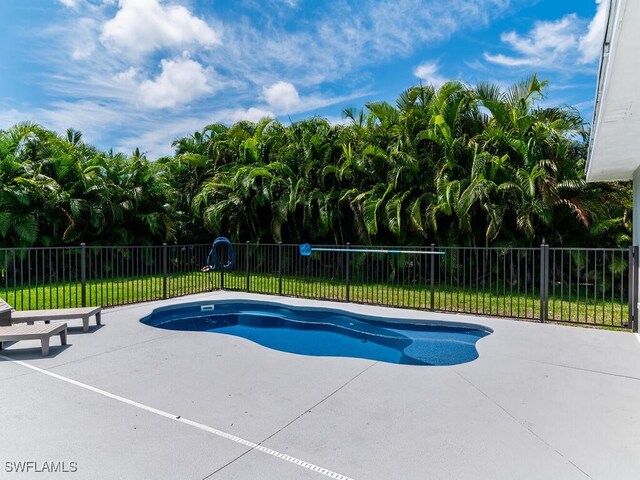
{"left": 0, "top": 243, "right": 638, "bottom": 331}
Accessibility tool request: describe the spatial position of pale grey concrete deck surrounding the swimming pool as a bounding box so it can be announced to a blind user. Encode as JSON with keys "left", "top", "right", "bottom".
{"left": 0, "top": 292, "right": 640, "bottom": 480}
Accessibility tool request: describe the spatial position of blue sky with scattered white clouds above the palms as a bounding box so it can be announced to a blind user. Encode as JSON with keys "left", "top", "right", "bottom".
{"left": 0, "top": 0, "right": 607, "bottom": 158}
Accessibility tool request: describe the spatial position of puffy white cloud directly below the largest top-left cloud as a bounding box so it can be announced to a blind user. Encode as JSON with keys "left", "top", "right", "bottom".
{"left": 138, "top": 57, "right": 213, "bottom": 108}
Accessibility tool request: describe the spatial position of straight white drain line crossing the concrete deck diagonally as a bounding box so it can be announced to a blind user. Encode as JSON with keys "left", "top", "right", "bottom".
{"left": 0, "top": 355, "right": 354, "bottom": 480}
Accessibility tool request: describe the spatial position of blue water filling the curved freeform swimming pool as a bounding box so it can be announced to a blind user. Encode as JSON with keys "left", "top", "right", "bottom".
{"left": 141, "top": 301, "right": 491, "bottom": 365}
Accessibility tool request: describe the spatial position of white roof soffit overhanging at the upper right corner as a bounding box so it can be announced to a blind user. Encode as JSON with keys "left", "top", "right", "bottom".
{"left": 587, "top": 0, "right": 640, "bottom": 182}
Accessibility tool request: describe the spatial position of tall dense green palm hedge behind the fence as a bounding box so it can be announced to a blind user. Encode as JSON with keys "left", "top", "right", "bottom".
{"left": 0, "top": 76, "right": 631, "bottom": 246}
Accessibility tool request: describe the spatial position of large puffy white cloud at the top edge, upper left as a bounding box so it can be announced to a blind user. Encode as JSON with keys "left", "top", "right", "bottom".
{"left": 101, "top": 0, "right": 220, "bottom": 54}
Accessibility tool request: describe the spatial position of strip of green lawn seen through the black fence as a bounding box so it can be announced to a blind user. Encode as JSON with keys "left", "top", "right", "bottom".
{"left": 0, "top": 272, "right": 628, "bottom": 327}
